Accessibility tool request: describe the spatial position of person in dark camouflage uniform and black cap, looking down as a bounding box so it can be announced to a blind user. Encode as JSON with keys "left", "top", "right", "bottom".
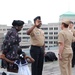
{"left": 2, "top": 20, "right": 24, "bottom": 72}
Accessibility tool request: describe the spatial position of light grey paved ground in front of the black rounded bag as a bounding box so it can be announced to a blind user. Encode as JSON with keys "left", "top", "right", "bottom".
{"left": 43, "top": 61, "right": 75, "bottom": 75}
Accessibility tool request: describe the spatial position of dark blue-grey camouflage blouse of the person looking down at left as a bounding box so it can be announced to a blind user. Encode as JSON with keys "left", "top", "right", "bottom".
{"left": 2, "top": 27, "right": 21, "bottom": 72}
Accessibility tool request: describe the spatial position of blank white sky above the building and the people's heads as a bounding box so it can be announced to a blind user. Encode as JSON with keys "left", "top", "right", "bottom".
{"left": 0, "top": 0, "right": 75, "bottom": 26}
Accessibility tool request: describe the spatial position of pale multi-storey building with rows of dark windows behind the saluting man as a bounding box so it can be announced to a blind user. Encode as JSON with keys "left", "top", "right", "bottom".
{"left": 0, "top": 23, "right": 59, "bottom": 48}
